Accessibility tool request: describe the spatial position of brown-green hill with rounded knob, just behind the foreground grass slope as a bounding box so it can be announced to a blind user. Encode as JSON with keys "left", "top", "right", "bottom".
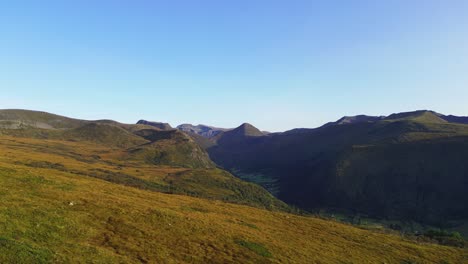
{"left": 0, "top": 110, "right": 290, "bottom": 211}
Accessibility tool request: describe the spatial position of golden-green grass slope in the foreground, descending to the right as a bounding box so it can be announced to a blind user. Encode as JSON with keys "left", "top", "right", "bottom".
{"left": 0, "top": 148, "right": 463, "bottom": 263}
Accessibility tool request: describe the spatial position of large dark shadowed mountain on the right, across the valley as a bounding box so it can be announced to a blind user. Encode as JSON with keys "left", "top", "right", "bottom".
{"left": 207, "top": 111, "right": 468, "bottom": 224}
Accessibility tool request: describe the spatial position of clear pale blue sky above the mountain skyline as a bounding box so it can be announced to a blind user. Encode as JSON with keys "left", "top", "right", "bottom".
{"left": 0, "top": 0, "right": 468, "bottom": 131}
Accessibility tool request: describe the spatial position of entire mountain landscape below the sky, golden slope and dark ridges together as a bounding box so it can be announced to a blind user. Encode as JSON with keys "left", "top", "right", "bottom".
{"left": 0, "top": 110, "right": 468, "bottom": 263}
